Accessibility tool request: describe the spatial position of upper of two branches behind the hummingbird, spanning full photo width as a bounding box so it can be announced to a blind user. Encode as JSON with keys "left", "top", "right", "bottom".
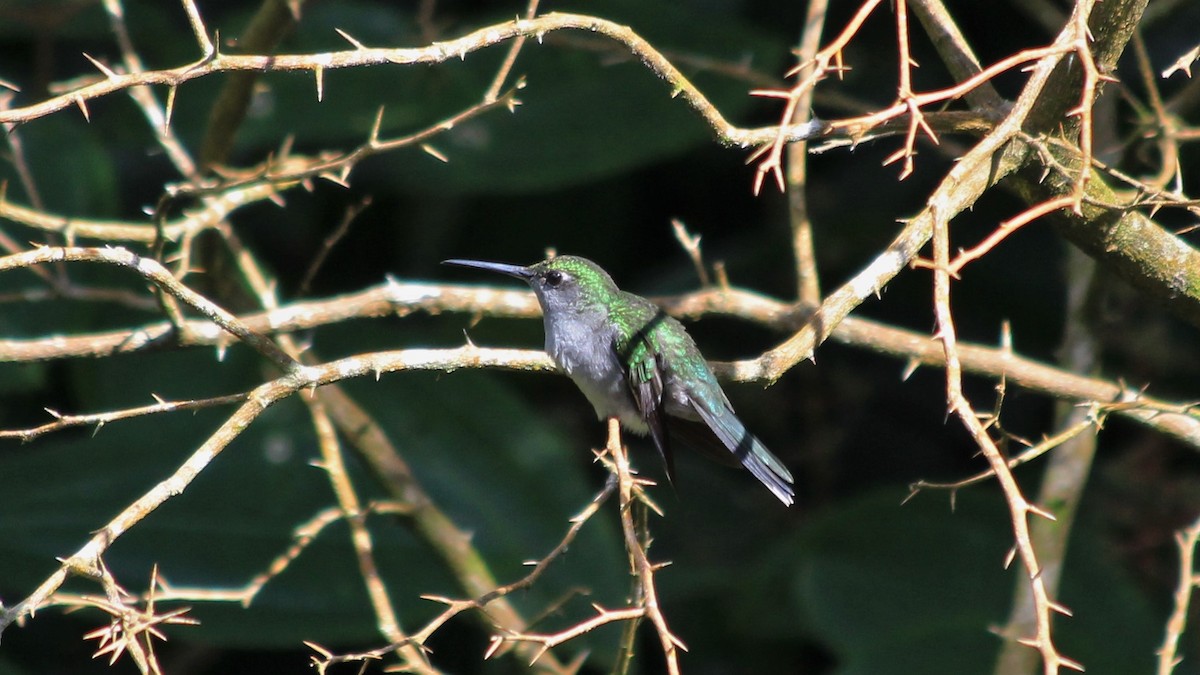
{"left": 0, "top": 281, "right": 1200, "bottom": 447}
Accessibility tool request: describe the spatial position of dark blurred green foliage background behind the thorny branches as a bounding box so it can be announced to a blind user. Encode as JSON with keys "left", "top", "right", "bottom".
{"left": 0, "top": 0, "right": 1200, "bottom": 675}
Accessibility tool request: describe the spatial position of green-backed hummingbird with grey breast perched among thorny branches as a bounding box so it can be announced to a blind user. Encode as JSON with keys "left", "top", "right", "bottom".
{"left": 442, "top": 256, "right": 796, "bottom": 506}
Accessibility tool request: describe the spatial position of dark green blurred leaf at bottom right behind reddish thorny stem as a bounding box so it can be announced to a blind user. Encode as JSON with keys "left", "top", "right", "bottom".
{"left": 749, "top": 488, "right": 1158, "bottom": 675}
